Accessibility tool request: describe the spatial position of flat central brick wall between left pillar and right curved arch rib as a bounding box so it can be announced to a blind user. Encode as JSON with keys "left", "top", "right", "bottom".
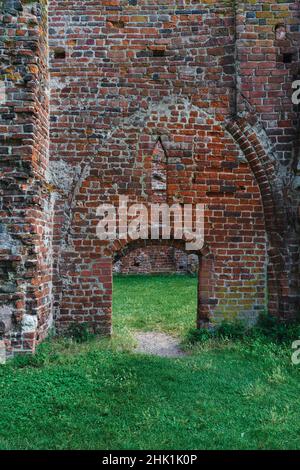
{"left": 49, "top": 0, "right": 266, "bottom": 332}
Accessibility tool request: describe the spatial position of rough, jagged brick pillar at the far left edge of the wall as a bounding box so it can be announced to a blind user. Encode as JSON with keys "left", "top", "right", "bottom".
{"left": 0, "top": 0, "right": 53, "bottom": 355}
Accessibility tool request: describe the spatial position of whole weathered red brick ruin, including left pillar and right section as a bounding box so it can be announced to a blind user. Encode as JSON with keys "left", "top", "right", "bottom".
{"left": 0, "top": 0, "right": 300, "bottom": 356}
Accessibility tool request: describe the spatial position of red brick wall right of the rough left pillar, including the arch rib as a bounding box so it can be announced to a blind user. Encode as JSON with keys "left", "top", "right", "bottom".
{"left": 46, "top": 0, "right": 299, "bottom": 328}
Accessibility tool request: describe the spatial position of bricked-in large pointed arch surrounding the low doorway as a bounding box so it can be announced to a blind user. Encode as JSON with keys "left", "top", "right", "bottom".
{"left": 55, "top": 97, "right": 269, "bottom": 334}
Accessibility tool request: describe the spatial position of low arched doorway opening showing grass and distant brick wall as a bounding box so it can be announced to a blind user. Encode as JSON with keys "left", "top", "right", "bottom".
{"left": 113, "top": 244, "right": 199, "bottom": 337}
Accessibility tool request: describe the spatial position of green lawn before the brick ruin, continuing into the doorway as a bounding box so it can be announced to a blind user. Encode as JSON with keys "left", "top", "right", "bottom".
{"left": 0, "top": 277, "right": 300, "bottom": 450}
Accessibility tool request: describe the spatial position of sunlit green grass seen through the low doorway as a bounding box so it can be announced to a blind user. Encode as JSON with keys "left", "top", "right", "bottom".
{"left": 113, "top": 274, "right": 198, "bottom": 336}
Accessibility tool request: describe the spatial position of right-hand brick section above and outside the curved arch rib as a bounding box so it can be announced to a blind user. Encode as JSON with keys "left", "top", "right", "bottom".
{"left": 233, "top": 0, "right": 300, "bottom": 317}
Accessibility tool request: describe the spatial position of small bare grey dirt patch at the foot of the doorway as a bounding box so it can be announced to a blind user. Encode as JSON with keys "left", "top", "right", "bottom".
{"left": 135, "top": 332, "right": 185, "bottom": 357}
